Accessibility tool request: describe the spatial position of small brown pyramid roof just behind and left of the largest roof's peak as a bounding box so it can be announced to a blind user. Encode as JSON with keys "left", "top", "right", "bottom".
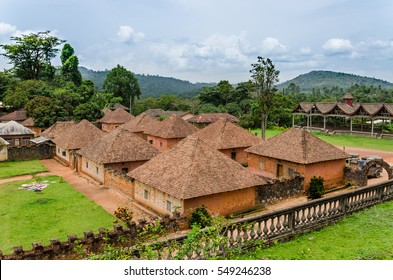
{"left": 145, "top": 116, "right": 198, "bottom": 139}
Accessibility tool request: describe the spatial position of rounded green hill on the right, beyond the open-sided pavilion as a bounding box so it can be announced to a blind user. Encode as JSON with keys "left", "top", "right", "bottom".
{"left": 277, "top": 71, "right": 393, "bottom": 92}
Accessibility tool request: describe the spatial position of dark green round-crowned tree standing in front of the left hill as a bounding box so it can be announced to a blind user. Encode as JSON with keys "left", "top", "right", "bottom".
{"left": 103, "top": 65, "right": 141, "bottom": 114}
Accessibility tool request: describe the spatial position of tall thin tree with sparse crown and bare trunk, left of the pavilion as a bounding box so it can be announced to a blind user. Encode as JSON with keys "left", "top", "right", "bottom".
{"left": 250, "top": 56, "right": 280, "bottom": 139}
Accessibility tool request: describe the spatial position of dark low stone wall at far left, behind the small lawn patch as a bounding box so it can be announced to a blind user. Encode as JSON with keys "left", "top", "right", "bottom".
{"left": 8, "top": 144, "right": 54, "bottom": 160}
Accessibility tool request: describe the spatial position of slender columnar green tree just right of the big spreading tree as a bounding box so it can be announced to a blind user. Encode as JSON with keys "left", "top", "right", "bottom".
{"left": 60, "top": 44, "right": 82, "bottom": 86}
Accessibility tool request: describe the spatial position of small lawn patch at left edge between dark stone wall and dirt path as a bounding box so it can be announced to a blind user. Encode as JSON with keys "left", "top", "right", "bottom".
{"left": 0, "top": 160, "right": 48, "bottom": 179}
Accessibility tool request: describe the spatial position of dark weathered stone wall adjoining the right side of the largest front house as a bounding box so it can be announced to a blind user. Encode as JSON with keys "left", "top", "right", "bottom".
{"left": 255, "top": 176, "right": 304, "bottom": 206}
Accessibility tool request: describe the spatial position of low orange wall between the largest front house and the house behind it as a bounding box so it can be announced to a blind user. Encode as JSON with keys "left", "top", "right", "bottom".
{"left": 104, "top": 168, "right": 135, "bottom": 198}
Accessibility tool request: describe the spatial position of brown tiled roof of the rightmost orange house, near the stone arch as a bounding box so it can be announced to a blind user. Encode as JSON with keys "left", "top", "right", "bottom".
{"left": 245, "top": 128, "right": 348, "bottom": 164}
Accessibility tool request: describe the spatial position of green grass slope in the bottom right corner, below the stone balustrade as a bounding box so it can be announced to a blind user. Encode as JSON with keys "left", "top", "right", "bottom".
{"left": 239, "top": 201, "right": 393, "bottom": 260}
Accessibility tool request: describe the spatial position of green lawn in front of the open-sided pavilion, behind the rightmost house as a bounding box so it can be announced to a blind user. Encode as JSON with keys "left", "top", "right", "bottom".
{"left": 251, "top": 128, "right": 393, "bottom": 152}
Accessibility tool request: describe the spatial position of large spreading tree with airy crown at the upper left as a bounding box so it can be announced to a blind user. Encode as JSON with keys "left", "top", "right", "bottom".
{"left": 0, "top": 31, "right": 65, "bottom": 80}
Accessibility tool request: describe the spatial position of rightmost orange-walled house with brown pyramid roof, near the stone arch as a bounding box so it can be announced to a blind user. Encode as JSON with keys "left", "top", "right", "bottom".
{"left": 245, "top": 128, "right": 348, "bottom": 188}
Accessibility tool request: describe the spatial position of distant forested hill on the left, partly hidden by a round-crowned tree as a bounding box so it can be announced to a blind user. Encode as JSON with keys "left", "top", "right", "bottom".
{"left": 79, "top": 67, "right": 215, "bottom": 97}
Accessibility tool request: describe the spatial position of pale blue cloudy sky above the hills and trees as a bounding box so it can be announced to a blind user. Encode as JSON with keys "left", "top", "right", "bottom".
{"left": 0, "top": 0, "right": 393, "bottom": 83}
